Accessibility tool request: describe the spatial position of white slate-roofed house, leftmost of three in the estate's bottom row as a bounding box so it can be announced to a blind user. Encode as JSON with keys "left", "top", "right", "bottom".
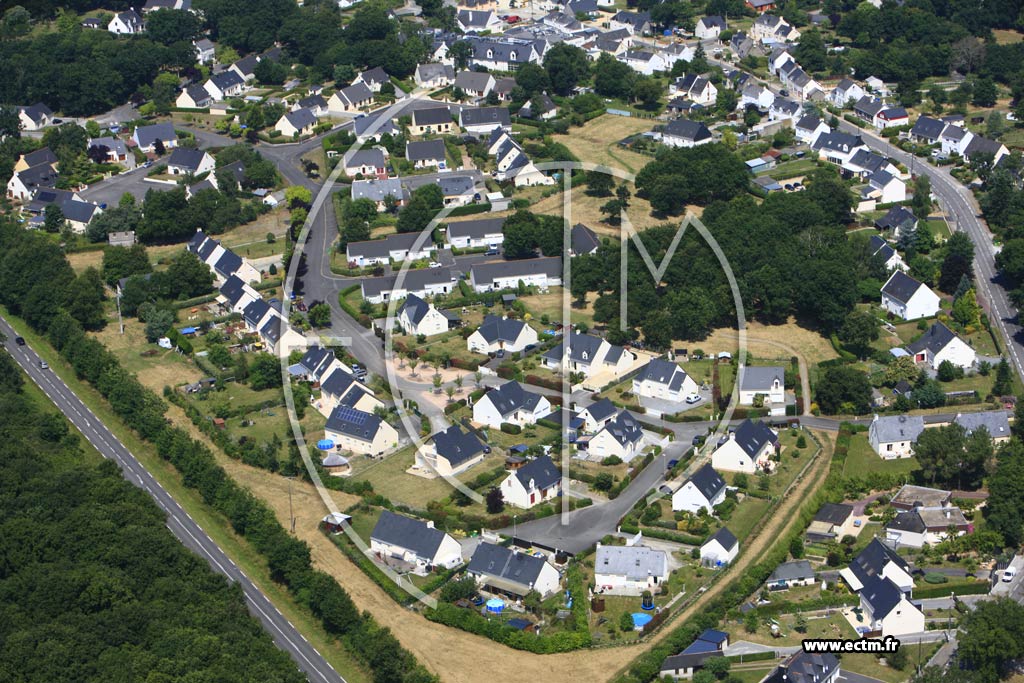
{"left": 370, "top": 510, "right": 462, "bottom": 575}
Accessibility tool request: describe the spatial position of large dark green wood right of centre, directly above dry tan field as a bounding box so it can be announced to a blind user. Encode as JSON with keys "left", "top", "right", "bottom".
{"left": 571, "top": 165, "right": 880, "bottom": 348}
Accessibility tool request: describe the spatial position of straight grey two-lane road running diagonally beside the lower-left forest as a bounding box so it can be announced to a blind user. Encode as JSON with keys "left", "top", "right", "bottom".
{"left": 0, "top": 317, "right": 345, "bottom": 683}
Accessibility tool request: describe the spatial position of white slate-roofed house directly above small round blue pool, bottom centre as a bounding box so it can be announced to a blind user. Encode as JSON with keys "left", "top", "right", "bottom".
{"left": 466, "top": 543, "right": 560, "bottom": 599}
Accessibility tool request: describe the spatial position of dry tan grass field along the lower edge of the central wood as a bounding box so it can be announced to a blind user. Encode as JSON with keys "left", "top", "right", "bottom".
{"left": 704, "top": 321, "right": 839, "bottom": 365}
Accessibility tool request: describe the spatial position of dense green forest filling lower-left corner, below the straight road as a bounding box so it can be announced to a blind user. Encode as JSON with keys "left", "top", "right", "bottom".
{"left": 0, "top": 353, "right": 304, "bottom": 683}
